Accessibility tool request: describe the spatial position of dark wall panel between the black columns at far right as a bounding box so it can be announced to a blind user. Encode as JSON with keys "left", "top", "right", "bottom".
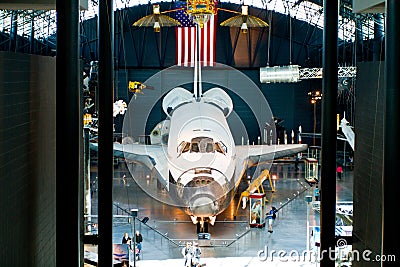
{"left": 353, "top": 62, "right": 385, "bottom": 267}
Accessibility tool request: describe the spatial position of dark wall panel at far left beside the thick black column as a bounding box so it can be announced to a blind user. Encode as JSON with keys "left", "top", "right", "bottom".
{"left": 0, "top": 52, "right": 56, "bottom": 266}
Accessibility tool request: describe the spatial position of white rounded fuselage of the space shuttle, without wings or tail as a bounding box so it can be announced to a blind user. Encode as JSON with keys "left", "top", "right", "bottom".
{"left": 168, "top": 100, "right": 236, "bottom": 222}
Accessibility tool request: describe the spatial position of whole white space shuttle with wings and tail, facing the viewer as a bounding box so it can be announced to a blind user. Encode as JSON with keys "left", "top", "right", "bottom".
{"left": 91, "top": 19, "right": 307, "bottom": 233}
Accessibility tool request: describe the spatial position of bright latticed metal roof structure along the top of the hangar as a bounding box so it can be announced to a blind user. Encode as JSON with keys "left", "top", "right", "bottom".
{"left": 0, "top": 0, "right": 384, "bottom": 45}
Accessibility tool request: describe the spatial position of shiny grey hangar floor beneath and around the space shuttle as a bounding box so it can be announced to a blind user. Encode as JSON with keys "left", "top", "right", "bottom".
{"left": 86, "top": 162, "right": 353, "bottom": 267}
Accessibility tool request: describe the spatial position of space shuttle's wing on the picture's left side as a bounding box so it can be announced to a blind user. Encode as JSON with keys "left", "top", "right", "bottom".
{"left": 90, "top": 142, "right": 169, "bottom": 189}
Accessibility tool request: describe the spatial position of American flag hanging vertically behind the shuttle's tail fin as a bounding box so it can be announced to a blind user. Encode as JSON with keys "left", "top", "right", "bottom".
{"left": 175, "top": 1, "right": 217, "bottom": 67}
